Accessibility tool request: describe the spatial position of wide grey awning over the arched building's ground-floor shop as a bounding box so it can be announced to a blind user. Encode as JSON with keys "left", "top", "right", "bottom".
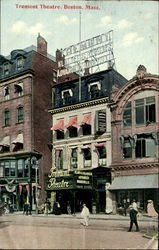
{"left": 109, "top": 174, "right": 158, "bottom": 190}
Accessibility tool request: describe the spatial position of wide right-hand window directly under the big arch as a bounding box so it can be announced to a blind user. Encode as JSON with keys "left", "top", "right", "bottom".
{"left": 135, "top": 96, "right": 156, "bottom": 125}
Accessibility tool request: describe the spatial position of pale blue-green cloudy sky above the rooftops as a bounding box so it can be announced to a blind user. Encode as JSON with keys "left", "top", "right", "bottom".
{"left": 0, "top": 0, "right": 159, "bottom": 80}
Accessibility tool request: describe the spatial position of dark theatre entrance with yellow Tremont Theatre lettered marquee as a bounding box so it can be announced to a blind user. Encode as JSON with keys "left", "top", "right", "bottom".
{"left": 46, "top": 167, "right": 110, "bottom": 213}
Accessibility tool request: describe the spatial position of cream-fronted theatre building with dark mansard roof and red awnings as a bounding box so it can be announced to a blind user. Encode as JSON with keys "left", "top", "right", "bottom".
{"left": 46, "top": 67, "right": 126, "bottom": 213}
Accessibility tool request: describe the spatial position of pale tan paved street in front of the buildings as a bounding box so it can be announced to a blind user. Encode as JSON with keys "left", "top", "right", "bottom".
{"left": 0, "top": 214, "right": 157, "bottom": 249}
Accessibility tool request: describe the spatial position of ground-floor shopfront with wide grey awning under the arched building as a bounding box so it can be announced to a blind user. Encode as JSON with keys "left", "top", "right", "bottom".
{"left": 109, "top": 174, "right": 159, "bottom": 212}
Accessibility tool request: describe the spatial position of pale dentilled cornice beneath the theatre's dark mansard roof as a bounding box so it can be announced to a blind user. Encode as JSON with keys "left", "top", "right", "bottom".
{"left": 48, "top": 97, "right": 109, "bottom": 114}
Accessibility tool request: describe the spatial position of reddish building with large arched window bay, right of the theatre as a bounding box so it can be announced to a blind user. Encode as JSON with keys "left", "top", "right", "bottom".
{"left": 109, "top": 65, "right": 159, "bottom": 211}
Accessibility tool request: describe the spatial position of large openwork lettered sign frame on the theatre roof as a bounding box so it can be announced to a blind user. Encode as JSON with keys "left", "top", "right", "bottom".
{"left": 62, "top": 30, "right": 114, "bottom": 74}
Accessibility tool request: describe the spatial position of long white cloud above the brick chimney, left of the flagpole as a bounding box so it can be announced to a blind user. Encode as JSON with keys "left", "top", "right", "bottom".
{"left": 10, "top": 21, "right": 51, "bottom": 35}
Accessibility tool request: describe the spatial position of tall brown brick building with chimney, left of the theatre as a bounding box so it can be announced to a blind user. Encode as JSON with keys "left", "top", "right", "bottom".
{"left": 0, "top": 35, "right": 57, "bottom": 210}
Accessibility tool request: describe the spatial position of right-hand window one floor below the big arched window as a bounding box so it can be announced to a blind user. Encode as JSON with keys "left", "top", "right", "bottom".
{"left": 135, "top": 135, "right": 156, "bottom": 158}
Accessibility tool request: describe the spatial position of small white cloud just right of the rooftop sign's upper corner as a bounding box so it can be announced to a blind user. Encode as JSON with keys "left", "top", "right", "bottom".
{"left": 121, "top": 32, "right": 144, "bottom": 47}
